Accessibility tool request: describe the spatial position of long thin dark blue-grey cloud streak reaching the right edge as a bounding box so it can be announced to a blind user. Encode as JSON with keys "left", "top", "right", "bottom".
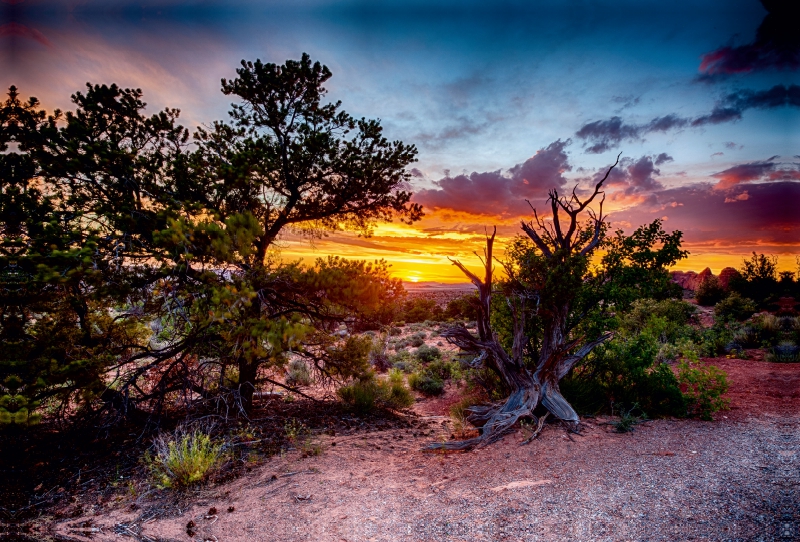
{"left": 575, "top": 85, "right": 800, "bottom": 153}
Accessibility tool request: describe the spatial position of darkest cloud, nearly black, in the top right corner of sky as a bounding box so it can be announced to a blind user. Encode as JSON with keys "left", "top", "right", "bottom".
{"left": 699, "top": 5, "right": 800, "bottom": 82}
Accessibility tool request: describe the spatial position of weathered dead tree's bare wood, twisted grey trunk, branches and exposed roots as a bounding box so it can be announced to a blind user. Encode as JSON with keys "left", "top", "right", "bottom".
{"left": 428, "top": 156, "right": 619, "bottom": 450}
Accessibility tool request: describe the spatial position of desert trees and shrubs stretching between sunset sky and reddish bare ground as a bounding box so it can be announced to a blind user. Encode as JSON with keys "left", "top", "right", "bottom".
{"left": 0, "top": 55, "right": 800, "bottom": 540}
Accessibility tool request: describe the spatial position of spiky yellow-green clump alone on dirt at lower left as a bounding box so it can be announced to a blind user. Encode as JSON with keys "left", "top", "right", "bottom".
{"left": 145, "top": 429, "right": 223, "bottom": 488}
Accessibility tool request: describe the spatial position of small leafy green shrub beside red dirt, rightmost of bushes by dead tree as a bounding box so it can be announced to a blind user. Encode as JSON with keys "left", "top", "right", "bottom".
{"left": 678, "top": 357, "right": 728, "bottom": 420}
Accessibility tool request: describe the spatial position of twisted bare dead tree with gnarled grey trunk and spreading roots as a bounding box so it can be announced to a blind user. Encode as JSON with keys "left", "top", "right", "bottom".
{"left": 428, "top": 156, "right": 619, "bottom": 450}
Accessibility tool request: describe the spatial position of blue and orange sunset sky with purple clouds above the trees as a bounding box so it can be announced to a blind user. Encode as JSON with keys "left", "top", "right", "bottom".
{"left": 0, "top": 0, "right": 800, "bottom": 282}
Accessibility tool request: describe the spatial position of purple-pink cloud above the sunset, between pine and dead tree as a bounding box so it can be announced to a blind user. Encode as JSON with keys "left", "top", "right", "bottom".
{"left": 414, "top": 140, "right": 572, "bottom": 218}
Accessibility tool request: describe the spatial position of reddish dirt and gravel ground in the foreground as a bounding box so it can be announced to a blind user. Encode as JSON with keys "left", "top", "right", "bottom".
{"left": 51, "top": 359, "right": 800, "bottom": 542}
